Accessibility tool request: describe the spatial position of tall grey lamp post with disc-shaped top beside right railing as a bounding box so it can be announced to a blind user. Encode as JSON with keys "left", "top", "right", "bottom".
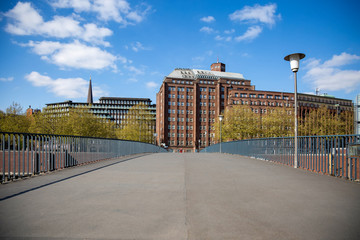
{"left": 284, "top": 53, "right": 305, "bottom": 168}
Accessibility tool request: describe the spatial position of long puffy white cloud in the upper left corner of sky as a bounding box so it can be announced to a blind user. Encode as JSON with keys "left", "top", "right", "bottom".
{"left": 4, "top": 2, "right": 113, "bottom": 46}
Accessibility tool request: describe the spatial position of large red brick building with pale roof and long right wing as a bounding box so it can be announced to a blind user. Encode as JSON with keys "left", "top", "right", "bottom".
{"left": 156, "top": 62, "right": 352, "bottom": 151}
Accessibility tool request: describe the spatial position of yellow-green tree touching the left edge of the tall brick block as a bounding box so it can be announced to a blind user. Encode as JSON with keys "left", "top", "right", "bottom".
{"left": 116, "top": 104, "right": 155, "bottom": 143}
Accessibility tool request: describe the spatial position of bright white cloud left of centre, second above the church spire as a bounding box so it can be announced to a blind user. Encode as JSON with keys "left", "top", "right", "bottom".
{"left": 23, "top": 40, "right": 118, "bottom": 70}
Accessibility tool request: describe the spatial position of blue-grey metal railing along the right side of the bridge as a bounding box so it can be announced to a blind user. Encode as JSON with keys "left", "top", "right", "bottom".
{"left": 202, "top": 135, "right": 360, "bottom": 180}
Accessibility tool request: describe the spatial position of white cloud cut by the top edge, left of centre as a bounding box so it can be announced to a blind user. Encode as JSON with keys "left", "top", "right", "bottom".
{"left": 51, "top": 0, "right": 151, "bottom": 26}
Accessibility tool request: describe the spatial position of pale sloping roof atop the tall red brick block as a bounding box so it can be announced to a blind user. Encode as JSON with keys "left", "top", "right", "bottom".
{"left": 167, "top": 68, "right": 245, "bottom": 80}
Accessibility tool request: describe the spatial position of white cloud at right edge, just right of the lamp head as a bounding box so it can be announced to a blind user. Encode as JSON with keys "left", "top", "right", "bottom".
{"left": 304, "top": 53, "right": 360, "bottom": 92}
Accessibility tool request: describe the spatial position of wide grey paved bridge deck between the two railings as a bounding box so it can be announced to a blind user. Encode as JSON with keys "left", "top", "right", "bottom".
{"left": 0, "top": 153, "right": 360, "bottom": 239}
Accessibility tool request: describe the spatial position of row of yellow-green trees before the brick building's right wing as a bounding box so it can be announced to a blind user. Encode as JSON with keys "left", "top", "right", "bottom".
{"left": 214, "top": 105, "right": 353, "bottom": 141}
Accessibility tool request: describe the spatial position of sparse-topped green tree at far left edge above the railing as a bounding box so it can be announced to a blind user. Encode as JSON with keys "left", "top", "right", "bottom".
{"left": 0, "top": 102, "right": 31, "bottom": 133}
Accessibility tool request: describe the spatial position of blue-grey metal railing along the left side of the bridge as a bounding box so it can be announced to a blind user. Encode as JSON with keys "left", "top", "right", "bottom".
{"left": 0, "top": 132, "right": 166, "bottom": 183}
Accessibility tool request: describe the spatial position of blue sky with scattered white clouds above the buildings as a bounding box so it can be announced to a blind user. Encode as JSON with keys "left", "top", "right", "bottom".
{"left": 0, "top": 0, "right": 360, "bottom": 110}
